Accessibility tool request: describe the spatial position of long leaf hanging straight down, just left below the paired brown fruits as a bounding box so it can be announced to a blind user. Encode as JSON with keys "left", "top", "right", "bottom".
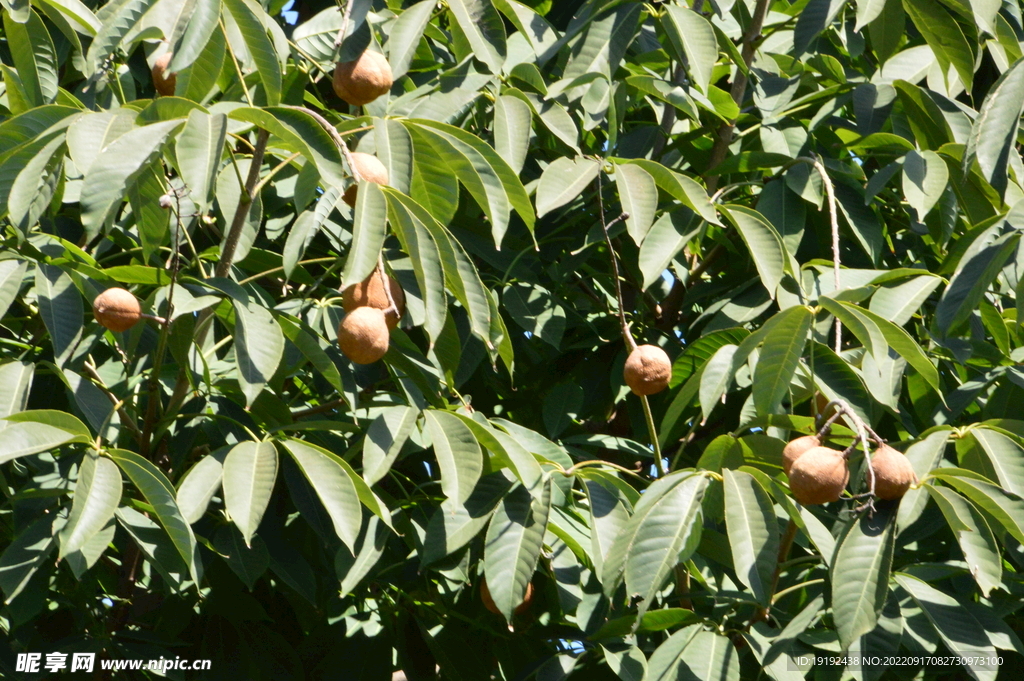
{"left": 722, "top": 469, "right": 778, "bottom": 605}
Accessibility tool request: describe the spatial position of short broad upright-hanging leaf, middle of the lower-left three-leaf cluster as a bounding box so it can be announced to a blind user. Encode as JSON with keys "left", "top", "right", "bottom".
{"left": 221, "top": 441, "right": 278, "bottom": 547}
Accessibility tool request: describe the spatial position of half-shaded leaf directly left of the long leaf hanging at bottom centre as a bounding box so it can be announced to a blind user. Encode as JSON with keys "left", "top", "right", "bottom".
{"left": 423, "top": 473, "right": 512, "bottom": 565}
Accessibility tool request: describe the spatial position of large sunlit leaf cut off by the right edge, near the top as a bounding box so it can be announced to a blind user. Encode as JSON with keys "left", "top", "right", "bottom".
{"left": 964, "top": 60, "right": 1024, "bottom": 197}
